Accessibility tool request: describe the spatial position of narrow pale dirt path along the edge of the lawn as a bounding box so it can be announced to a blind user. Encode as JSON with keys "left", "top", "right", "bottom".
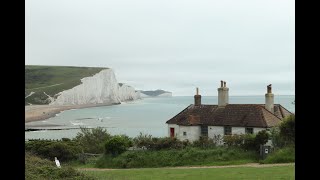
{"left": 78, "top": 163, "right": 295, "bottom": 171}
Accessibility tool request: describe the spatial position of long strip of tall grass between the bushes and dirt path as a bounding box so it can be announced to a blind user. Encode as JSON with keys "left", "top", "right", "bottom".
{"left": 96, "top": 147, "right": 258, "bottom": 168}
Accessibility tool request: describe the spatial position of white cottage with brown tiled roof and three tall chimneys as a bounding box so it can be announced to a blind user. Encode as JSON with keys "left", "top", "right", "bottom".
{"left": 166, "top": 81, "right": 292, "bottom": 143}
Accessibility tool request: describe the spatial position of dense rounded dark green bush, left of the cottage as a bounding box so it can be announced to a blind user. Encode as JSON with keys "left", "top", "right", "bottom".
{"left": 105, "top": 135, "right": 132, "bottom": 156}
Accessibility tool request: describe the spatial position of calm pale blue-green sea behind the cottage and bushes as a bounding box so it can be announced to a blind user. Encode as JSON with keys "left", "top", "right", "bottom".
{"left": 25, "top": 96, "right": 295, "bottom": 139}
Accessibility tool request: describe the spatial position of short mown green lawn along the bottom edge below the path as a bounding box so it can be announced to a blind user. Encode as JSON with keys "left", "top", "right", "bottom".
{"left": 82, "top": 165, "right": 295, "bottom": 180}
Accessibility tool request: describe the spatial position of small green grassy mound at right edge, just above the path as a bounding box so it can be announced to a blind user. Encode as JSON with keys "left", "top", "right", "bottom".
{"left": 261, "top": 147, "right": 295, "bottom": 164}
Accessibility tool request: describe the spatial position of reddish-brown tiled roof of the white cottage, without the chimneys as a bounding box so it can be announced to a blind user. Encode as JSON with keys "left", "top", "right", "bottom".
{"left": 166, "top": 104, "right": 292, "bottom": 128}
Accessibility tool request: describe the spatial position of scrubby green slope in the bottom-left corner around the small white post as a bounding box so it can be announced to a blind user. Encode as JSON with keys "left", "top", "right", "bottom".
{"left": 25, "top": 153, "right": 96, "bottom": 180}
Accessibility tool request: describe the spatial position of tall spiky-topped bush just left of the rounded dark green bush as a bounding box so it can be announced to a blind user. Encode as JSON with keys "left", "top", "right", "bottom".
{"left": 74, "top": 127, "right": 111, "bottom": 154}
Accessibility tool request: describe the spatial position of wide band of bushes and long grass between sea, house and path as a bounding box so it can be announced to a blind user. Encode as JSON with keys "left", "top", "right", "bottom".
{"left": 25, "top": 121, "right": 295, "bottom": 175}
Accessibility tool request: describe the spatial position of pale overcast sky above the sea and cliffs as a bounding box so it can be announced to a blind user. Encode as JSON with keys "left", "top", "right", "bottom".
{"left": 25, "top": 0, "right": 295, "bottom": 96}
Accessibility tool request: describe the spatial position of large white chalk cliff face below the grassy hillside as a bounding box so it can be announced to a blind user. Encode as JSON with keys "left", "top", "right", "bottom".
{"left": 50, "top": 69, "right": 141, "bottom": 105}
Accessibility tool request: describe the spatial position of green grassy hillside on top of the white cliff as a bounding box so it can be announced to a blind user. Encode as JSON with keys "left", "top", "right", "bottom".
{"left": 25, "top": 65, "right": 107, "bottom": 104}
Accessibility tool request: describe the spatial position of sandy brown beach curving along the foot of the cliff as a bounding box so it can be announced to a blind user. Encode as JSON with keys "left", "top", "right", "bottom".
{"left": 25, "top": 103, "right": 121, "bottom": 123}
